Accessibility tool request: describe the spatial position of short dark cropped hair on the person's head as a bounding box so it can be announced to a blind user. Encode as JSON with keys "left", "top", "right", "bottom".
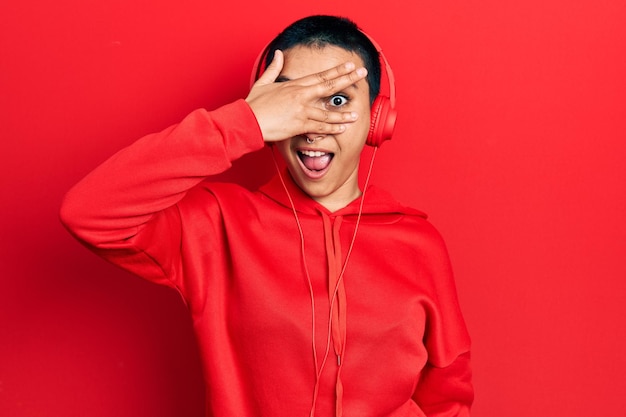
{"left": 265, "top": 15, "right": 381, "bottom": 104}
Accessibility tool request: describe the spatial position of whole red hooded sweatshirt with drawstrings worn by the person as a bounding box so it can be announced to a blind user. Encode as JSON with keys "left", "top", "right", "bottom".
{"left": 61, "top": 100, "right": 473, "bottom": 417}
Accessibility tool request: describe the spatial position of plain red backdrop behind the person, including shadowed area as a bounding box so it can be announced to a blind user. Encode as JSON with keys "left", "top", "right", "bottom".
{"left": 0, "top": 0, "right": 626, "bottom": 417}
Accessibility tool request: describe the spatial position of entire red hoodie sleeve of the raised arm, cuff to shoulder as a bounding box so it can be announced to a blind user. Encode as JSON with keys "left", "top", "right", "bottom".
{"left": 60, "top": 100, "right": 264, "bottom": 286}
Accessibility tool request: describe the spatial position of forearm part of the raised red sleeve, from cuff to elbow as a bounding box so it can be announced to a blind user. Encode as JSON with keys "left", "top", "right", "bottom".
{"left": 61, "top": 100, "right": 263, "bottom": 245}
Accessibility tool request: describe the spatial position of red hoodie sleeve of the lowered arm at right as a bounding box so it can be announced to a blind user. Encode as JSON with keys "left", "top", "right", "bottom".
{"left": 413, "top": 221, "right": 474, "bottom": 417}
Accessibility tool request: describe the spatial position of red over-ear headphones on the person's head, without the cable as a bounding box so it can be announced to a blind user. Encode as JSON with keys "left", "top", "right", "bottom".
{"left": 250, "top": 31, "right": 398, "bottom": 147}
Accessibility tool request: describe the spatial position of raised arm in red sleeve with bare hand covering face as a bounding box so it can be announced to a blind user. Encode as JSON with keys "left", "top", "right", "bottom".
{"left": 61, "top": 54, "right": 365, "bottom": 283}
